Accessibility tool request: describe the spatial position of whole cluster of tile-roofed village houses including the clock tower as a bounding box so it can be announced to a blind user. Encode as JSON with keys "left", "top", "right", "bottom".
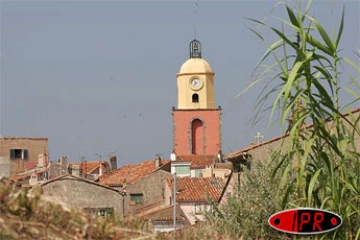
{"left": 0, "top": 40, "right": 360, "bottom": 232}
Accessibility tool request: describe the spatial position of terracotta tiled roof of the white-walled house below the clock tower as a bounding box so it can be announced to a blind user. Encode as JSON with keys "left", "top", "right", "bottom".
{"left": 167, "top": 177, "right": 225, "bottom": 202}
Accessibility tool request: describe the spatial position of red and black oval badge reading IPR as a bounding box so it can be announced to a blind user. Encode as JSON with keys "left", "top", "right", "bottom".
{"left": 268, "top": 208, "right": 342, "bottom": 234}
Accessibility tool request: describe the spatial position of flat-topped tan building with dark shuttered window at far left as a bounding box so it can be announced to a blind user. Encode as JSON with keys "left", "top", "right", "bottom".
{"left": 0, "top": 137, "right": 48, "bottom": 175}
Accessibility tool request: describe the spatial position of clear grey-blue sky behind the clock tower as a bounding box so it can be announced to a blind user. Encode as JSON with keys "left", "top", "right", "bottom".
{"left": 0, "top": 0, "right": 360, "bottom": 166}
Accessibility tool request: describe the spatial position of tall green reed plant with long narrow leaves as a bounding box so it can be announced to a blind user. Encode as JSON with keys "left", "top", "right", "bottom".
{"left": 236, "top": 1, "right": 360, "bottom": 239}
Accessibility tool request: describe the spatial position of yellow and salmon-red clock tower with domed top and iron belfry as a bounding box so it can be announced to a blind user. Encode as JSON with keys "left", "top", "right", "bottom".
{"left": 172, "top": 39, "right": 221, "bottom": 155}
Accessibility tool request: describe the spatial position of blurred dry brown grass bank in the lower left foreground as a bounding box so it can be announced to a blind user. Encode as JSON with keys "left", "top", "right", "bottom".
{"left": 0, "top": 178, "right": 156, "bottom": 240}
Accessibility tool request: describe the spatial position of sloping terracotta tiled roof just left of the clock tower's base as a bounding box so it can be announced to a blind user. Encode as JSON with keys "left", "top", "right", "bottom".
{"left": 99, "top": 159, "right": 170, "bottom": 186}
